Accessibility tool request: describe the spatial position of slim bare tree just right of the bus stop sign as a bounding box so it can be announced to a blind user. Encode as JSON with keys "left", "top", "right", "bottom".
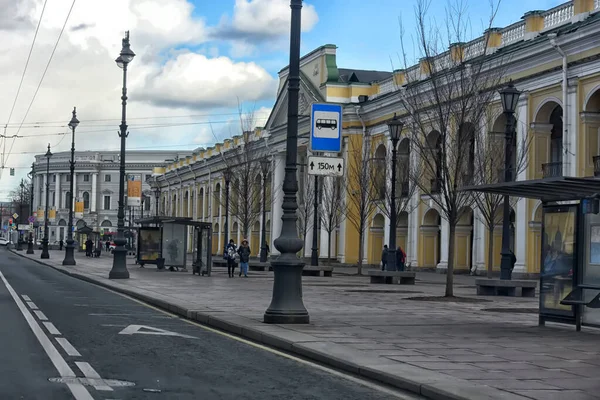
{"left": 343, "top": 132, "right": 377, "bottom": 275}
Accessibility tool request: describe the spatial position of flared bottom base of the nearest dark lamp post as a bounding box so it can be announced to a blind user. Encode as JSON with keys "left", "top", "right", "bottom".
{"left": 263, "top": 257, "right": 310, "bottom": 324}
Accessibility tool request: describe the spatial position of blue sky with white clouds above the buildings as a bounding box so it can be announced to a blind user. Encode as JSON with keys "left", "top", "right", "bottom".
{"left": 0, "top": 0, "right": 563, "bottom": 199}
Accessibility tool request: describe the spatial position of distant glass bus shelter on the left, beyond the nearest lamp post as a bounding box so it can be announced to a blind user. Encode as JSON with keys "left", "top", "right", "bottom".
{"left": 135, "top": 217, "right": 212, "bottom": 276}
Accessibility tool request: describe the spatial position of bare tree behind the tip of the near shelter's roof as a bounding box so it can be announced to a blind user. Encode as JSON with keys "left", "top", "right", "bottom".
{"left": 474, "top": 113, "right": 531, "bottom": 278}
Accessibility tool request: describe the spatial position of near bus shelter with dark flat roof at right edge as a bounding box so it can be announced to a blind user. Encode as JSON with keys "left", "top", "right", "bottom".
{"left": 462, "top": 177, "right": 600, "bottom": 331}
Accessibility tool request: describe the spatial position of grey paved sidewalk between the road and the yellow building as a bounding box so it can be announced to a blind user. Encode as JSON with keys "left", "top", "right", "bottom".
{"left": 11, "top": 251, "right": 600, "bottom": 400}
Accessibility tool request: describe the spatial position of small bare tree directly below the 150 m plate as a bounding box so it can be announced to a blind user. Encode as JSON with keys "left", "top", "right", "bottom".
{"left": 320, "top": 177, "right": 344, "bottom": 260}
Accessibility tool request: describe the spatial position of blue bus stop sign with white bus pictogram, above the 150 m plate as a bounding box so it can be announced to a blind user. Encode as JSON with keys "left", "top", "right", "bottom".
{"left": 310, "top": 104, "right": 342, "bottom": 153}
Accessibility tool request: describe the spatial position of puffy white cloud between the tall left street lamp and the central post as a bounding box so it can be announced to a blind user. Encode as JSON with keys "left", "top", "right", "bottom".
{"left": 140, "top": 52, "right": 276, "bottom": 108}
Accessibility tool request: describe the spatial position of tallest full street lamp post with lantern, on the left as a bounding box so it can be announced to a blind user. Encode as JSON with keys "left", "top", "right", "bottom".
{"left": 108, "top": 31, "right": 135, "bottom": 279}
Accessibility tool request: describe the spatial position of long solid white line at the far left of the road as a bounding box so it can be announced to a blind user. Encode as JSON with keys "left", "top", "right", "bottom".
{"left": 0, "top": 272, "right": 94, "bottom": 400}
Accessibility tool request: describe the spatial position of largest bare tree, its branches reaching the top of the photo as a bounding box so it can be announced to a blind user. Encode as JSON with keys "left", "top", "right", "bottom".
{"left": 400, "top": 0, "right": 503, "bottom": 297}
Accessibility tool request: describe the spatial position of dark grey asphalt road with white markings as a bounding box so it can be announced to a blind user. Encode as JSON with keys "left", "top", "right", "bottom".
{"left": 0, "top": 249, "right": 422, "bottom": 400}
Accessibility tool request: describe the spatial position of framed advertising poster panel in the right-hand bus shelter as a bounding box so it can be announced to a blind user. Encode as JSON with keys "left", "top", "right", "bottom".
{"left": 540, "top": 205, "right": 577, "bottom": 317}
